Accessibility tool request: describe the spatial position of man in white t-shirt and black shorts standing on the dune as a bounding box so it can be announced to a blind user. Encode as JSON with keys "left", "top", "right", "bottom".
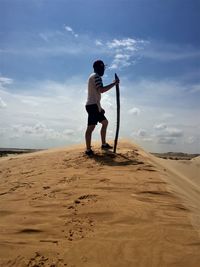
{"left": 85, "top": 60, "right": 119, "bottom": 156}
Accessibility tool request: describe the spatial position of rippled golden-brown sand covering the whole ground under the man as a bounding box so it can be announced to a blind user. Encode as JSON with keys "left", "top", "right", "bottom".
{"left": 0, "top": 141, "right": 200, "bottom": 267}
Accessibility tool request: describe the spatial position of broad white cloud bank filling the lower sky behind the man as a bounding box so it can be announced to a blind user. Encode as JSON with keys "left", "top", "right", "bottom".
{"left": 0, "top": 73, "right": 200, "bottom": 153}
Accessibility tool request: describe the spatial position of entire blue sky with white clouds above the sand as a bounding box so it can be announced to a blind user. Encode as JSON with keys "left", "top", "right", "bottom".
{"left": 0, "top": 0, "right": 200, "bottom": 153}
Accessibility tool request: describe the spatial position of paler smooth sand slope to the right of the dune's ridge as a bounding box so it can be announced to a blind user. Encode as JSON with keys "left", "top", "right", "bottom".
{"left": 153, "top": 154, "right": 200, "bottom": 240}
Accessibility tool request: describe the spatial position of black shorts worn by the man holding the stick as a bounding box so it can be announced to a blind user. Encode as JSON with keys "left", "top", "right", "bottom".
{"left": 85, "top": 104, "right": 106, "bottom": 125}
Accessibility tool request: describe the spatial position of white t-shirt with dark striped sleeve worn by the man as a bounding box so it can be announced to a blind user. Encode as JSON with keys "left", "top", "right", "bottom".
{"left": 86, "top": 73, "right": 103, "bottom": 112}
